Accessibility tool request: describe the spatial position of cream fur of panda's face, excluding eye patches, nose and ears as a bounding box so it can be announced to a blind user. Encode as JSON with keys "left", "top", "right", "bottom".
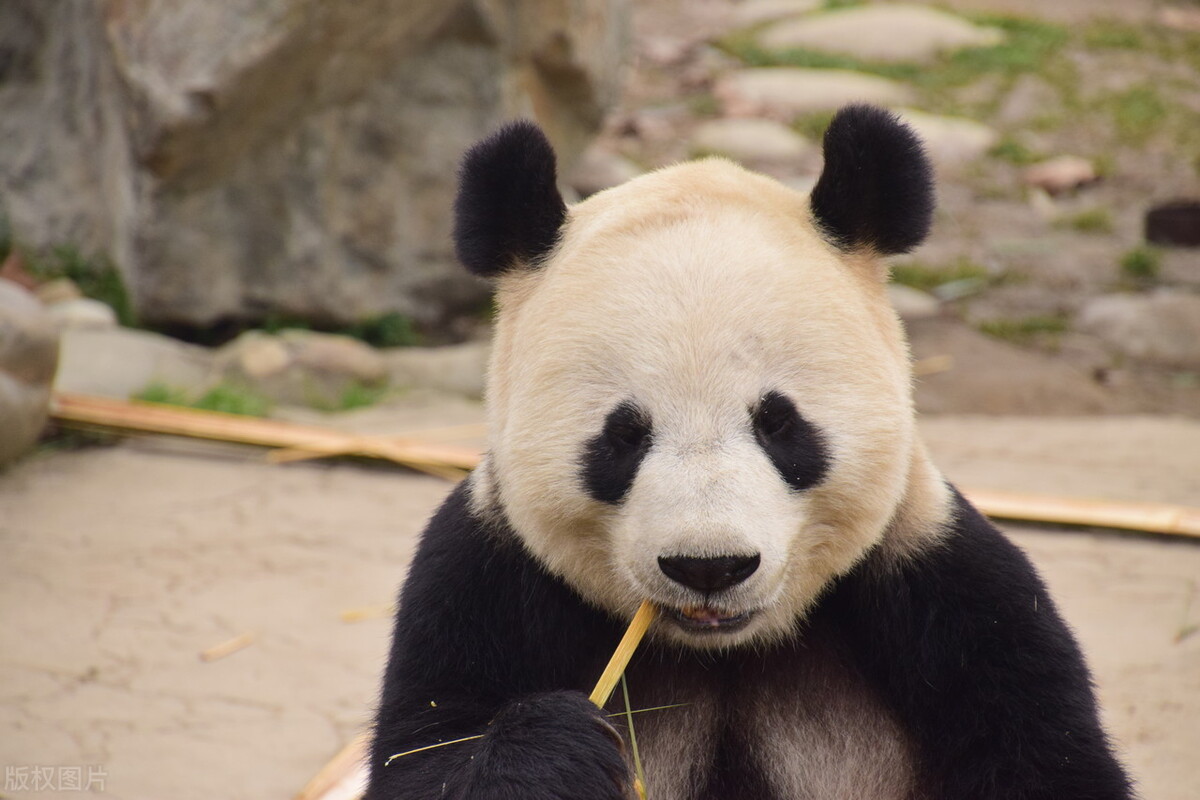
{"left": 473, "top": 160, "right": 948, "bottom": 646}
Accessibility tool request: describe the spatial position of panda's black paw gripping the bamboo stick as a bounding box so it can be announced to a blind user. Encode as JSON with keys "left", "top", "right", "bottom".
{"left": 460, "top": 692, "right": 635, "bottom": 800}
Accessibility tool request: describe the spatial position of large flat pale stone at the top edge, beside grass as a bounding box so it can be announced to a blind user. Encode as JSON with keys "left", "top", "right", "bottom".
{"left": 760, "top": 5, "right": 1004, "bottom": 61}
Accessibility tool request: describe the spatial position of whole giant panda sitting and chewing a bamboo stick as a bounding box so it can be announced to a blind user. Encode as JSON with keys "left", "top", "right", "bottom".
{"left": 367, "top": 106, "right": 1132, "bottom": 800}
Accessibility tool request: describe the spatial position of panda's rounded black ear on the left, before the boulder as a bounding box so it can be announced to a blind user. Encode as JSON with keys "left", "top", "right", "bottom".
{"left": 454, "top": 120, "right": 566, "bottom": 277}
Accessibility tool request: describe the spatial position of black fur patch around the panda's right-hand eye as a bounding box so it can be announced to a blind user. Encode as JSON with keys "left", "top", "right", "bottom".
{"left": 750, "top": 392, "right": 830, "bottom": 492}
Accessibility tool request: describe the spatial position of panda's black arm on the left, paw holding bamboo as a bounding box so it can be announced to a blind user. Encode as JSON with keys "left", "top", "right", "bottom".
{"left": 366, "top": 486, "right": 628, "bottom": 800}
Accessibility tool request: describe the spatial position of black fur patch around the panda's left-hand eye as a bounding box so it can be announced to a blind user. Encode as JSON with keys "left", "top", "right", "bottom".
{"left": 582, "top": 401, "right": 653, "bottom": 505}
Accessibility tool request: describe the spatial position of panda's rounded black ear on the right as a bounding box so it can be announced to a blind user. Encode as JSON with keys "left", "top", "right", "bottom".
{"left": 811, "top": 106, "right": 934, "bottom": 255}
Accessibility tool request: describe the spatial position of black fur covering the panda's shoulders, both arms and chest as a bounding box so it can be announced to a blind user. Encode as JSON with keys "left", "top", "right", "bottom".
{"left": 366, "top": 487, "right": 1130, "bottom": 800}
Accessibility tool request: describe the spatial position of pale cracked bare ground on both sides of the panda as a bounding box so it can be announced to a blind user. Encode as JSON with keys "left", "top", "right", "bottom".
{"left": 0, "top": 401, "right": 1200, "bottom": 800}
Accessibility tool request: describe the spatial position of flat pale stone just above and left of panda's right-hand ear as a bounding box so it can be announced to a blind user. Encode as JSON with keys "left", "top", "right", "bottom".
{"left": 715, "top": 67, "right": 912, "bottom": 121}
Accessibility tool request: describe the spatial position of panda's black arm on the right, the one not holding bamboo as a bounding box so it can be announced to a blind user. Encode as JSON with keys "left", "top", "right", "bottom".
{"left": 834, "top": 495, "right": 1133, "bottom": 800}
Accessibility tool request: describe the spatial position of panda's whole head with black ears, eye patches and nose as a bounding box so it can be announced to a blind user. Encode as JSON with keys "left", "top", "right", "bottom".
{"left": 455, "top": 106, "right": 944, "bottom": 646}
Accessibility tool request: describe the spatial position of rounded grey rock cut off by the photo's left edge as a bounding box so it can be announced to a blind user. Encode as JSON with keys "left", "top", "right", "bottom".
{"left": 0, "top": 278, "right": 59, "bottom": 465}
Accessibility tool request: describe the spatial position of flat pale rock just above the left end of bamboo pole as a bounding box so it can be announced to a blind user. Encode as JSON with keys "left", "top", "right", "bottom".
{"left": 54, "top": 327, "right": 212, "bottom": 399}
